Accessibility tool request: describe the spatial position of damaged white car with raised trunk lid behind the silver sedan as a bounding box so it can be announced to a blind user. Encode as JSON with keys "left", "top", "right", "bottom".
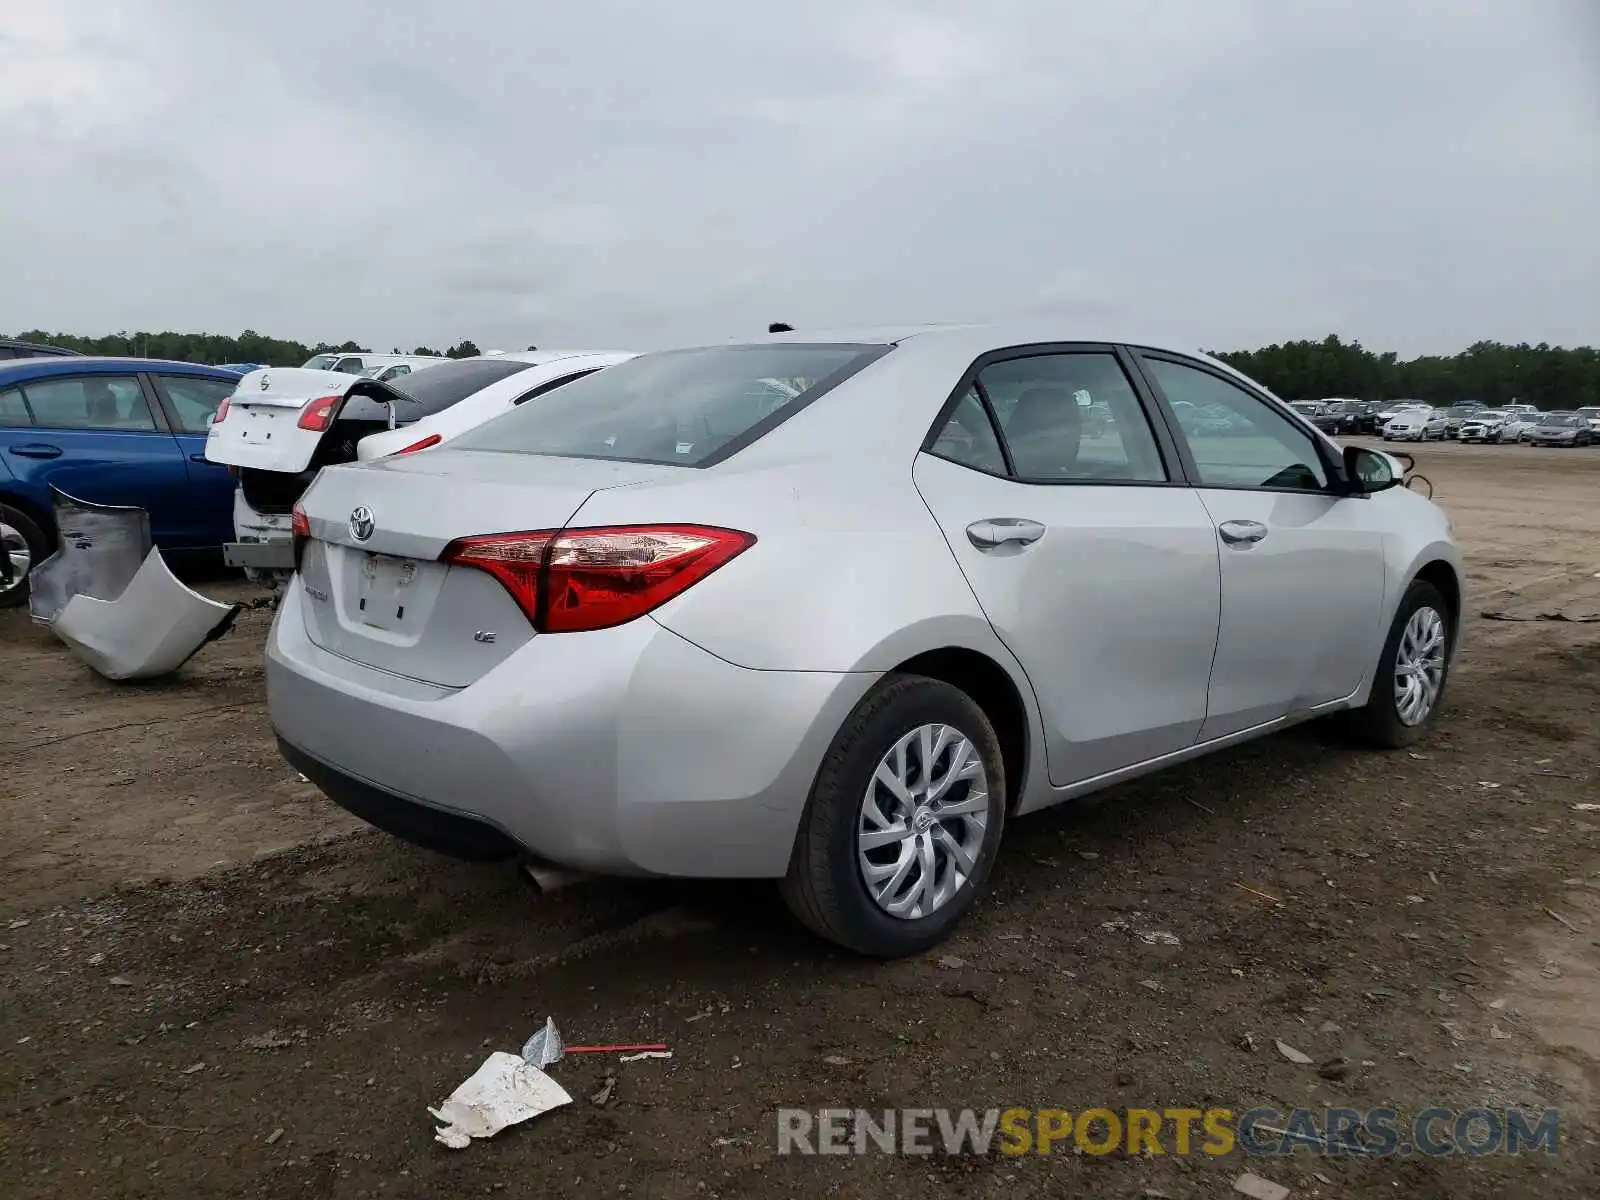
{"left": 205, "top": 350, "right": 630, "bottom": 579}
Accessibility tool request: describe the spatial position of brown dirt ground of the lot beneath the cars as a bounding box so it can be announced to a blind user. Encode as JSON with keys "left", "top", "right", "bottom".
{"left": 0, "top": 445, "right": 1600, "bottom": 1200}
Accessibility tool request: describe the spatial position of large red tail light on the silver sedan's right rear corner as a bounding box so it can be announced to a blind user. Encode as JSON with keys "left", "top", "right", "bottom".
{"left": 440, "top": 525, "right": 755, "bottom": 634}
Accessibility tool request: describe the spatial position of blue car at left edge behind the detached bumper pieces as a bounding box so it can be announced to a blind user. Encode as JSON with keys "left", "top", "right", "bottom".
{"left": 0, "top": 355, "right": 240, "bottom": 608}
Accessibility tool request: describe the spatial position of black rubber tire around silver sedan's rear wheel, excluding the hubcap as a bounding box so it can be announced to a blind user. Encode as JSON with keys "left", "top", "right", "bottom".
{"left": 779, "top": 675, "right": 1006, "bottom": 958}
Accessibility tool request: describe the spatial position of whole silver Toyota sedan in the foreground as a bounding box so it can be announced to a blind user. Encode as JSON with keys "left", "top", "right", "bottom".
{"left": 267, "top": 326, "right": 1462, "bottom": 955}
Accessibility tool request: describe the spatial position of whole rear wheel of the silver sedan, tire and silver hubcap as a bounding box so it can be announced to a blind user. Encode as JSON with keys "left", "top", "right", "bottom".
{"left": 781, "top": 675, "right": 1005, "bottom": 958}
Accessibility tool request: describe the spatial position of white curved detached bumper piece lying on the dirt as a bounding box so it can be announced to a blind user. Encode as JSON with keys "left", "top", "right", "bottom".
{"left": 51, "top": 550, "right": 243, "bottom": 680}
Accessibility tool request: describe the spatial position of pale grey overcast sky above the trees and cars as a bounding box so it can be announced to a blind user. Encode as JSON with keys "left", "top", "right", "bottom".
{"left": 0, "top": 0, "right": 1600, "bottom": 354}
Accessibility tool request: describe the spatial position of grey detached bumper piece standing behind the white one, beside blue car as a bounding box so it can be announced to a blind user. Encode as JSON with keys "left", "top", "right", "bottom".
{"left": 27, "top": 486, "right": 150, "bottom": 626}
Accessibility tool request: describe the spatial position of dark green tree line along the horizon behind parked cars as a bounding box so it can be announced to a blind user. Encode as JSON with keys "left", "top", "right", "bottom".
{"left": 6, "top": 330, "right": 1600, "bottom": 408}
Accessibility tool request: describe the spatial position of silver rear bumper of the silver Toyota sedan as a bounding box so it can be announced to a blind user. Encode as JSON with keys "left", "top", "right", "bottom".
{"left": 267, "top": 581, "right": 874, "bottom": 878}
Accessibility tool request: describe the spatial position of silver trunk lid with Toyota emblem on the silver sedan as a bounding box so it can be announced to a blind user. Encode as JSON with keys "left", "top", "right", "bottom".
{"left": 301, "top": 448, "right": 686, "bottom": 688}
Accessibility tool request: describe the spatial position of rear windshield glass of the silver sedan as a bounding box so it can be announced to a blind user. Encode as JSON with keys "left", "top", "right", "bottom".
{"left": 451, "top": 344, "right": 890, "bottom": 467}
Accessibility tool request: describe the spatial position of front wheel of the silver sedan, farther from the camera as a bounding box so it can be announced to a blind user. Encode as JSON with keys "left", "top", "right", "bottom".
{"left": 1352, "top": 579, "right": 1454, "bottom": 749}
